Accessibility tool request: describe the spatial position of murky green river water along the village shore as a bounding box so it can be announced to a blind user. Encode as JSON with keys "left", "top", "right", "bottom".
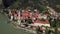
{"left": 0, "top": 14, "right": 31, "bottom": 34}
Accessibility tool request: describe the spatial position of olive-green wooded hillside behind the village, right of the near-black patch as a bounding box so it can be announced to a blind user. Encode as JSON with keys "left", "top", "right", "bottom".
{"left": 8, "top": 0, "right": 60, "bottom": 12}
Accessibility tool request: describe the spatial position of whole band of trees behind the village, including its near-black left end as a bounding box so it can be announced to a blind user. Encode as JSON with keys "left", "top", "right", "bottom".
{"left": 3, "top": 0, "right": 60, "bottom": 12}
